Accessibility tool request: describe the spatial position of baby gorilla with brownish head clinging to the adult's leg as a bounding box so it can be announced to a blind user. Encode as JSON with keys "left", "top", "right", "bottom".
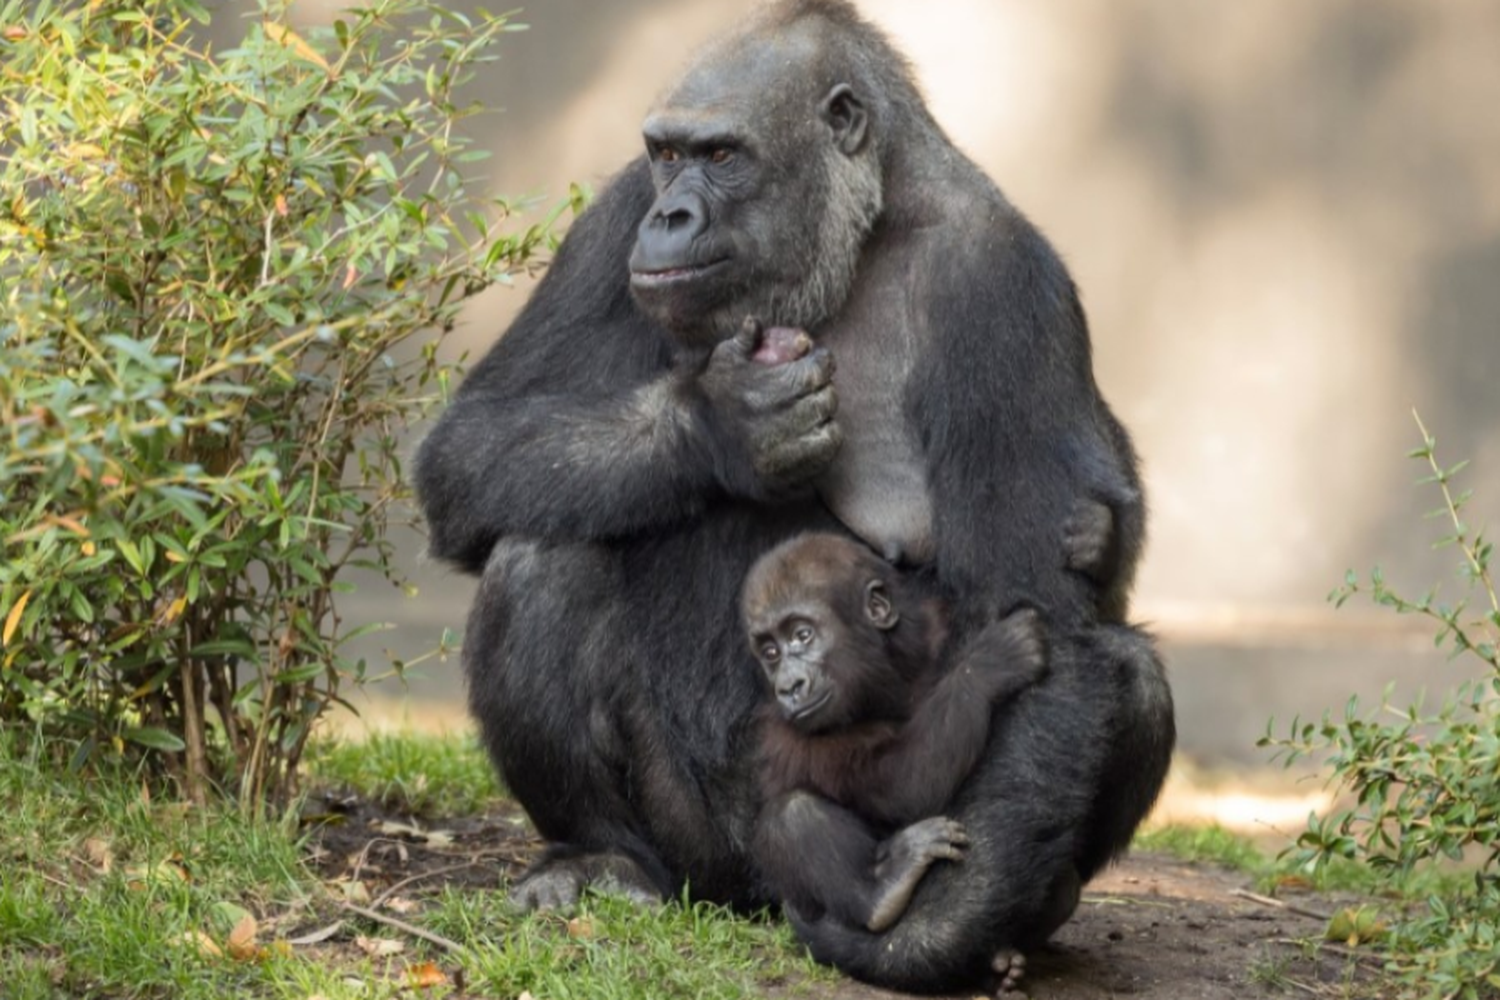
{"left": 743, "top": 534, "right": 1047, "bottom": 931}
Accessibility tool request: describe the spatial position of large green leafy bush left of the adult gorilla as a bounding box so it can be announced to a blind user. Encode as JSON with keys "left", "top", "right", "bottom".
{"left": 0, "top": 0, "right": 564, "bottom": 808}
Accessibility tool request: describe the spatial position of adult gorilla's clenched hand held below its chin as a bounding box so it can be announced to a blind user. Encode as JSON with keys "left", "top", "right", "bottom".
{"left": 698, "top": 319, "right": 843, "bottom": 499}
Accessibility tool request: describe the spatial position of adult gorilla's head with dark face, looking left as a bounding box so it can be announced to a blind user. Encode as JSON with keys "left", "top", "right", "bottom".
{"left": 630, "top": 25, "right": 881, "bottom": 345}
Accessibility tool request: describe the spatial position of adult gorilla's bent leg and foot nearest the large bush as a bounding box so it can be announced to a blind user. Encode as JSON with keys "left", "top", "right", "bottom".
{"left": 464, "top": 540, "right": 674, "bottom": 909}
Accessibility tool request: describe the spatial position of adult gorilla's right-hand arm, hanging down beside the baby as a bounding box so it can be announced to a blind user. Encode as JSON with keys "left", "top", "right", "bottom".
{"left": 909, "top": 214, "right": 1143, "bottom": 636}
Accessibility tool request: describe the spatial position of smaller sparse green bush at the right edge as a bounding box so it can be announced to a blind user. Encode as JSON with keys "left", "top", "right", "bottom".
{"left": 1262, "top": 420, "right": 1500, "bottom": 999}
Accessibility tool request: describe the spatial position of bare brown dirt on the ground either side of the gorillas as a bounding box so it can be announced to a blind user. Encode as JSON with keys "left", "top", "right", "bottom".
{"left": 304, "top": 801, "right": 1379, "bottom": 1000}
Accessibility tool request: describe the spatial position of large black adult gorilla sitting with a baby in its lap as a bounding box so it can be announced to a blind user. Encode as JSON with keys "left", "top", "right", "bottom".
{"left": 417, "top": 0, "right": 1173, "bottom": 990}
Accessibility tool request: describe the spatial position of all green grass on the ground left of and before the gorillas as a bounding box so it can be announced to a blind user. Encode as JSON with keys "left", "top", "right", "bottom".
{"left": 0, "top": 729, "right": 834, "bottom": 1000}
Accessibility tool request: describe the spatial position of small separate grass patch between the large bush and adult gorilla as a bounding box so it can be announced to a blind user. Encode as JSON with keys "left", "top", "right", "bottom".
{"left": 308, "top": 730, "right": 504, "bottom": 816}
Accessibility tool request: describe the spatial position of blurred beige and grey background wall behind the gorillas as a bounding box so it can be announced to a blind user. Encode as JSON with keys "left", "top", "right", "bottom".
{"left": 283, "top": 0, "right": 1500, "bottom": 762}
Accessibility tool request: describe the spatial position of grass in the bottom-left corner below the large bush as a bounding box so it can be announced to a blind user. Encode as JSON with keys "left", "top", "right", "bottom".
{"left": 0, "top": 730, "right": 343, "bottom": 1000}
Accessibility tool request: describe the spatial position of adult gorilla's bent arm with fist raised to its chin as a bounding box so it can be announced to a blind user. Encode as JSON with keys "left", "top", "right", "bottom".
{"left": 416, "top": 163, "right": 837, "bottom": 573}
